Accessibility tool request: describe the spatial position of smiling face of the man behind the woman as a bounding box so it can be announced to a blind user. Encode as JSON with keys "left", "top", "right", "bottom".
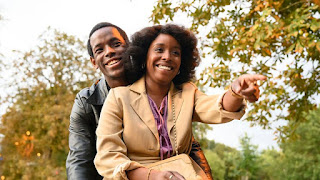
{"left": 90, "top": 27, "right": 127, "bottom": 80}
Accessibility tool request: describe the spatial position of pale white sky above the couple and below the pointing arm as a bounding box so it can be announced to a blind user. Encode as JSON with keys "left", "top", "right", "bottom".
{"left": 0, "top": 0, "right": 278, "bottom": 150}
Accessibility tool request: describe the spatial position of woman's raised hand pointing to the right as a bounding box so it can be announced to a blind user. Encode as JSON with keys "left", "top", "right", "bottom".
{"left": 230, "top": 74, "right": 267, "bottom": 102}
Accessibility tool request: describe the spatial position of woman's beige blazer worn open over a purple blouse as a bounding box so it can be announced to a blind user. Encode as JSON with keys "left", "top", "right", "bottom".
{"left": 94, "top": 77, "right": 245, "bottom": 179}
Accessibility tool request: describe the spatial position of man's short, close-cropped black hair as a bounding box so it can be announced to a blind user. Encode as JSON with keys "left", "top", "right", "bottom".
{"left": 87, "top": 22, "right": 129, "bottom": 57}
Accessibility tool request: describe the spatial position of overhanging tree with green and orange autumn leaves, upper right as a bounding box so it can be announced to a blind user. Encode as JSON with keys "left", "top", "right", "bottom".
{"left": 150, "top": 0, "right": 320, "bottom": 139}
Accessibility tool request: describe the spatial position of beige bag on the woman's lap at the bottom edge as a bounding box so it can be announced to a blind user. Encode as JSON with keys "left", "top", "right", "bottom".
{"left": 147, "top": 154, "right": 208, "bottom": 180}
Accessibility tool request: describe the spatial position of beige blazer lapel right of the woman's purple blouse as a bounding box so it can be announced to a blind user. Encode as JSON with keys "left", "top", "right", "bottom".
{"left": 167, "top": 83, "right": 183, "bottom": 134}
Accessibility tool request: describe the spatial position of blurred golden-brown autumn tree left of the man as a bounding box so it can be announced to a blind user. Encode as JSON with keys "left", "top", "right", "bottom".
{"left": 0, "top": 28, "right": 95, "bottom": 179}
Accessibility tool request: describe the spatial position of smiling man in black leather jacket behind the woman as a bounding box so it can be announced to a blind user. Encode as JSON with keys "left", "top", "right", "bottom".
{"left": 66, "top": 22, "right": 211, "bottom": 180}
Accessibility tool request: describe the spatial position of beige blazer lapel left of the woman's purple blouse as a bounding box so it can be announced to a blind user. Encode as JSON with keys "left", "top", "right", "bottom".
{"left": 130, "top": 77, "right": 159, "bottom": 142}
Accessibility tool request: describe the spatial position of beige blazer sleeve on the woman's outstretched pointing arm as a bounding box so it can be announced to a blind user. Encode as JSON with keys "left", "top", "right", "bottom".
{"left": 193, "top": 85, "right": 246, "bottom": 124}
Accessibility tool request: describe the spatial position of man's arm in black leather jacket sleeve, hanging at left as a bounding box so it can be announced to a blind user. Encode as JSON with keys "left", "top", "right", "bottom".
{"left": 66, "top": 94, "right": 102, "bottom": 180}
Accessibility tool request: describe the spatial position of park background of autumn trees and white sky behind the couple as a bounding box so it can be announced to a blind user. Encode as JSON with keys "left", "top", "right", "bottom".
{"left": 0, "top": 0, "right": 320, "bottom": 179}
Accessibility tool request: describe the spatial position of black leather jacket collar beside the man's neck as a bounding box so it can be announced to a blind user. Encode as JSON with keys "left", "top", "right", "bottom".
{"left": 87, "top": 78, "right": 110, "bottom": 105}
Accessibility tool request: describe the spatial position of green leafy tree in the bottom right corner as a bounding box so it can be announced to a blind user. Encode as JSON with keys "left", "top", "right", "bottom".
{"left": 279, "top": 109, "right": 320, "bottom": 180}
